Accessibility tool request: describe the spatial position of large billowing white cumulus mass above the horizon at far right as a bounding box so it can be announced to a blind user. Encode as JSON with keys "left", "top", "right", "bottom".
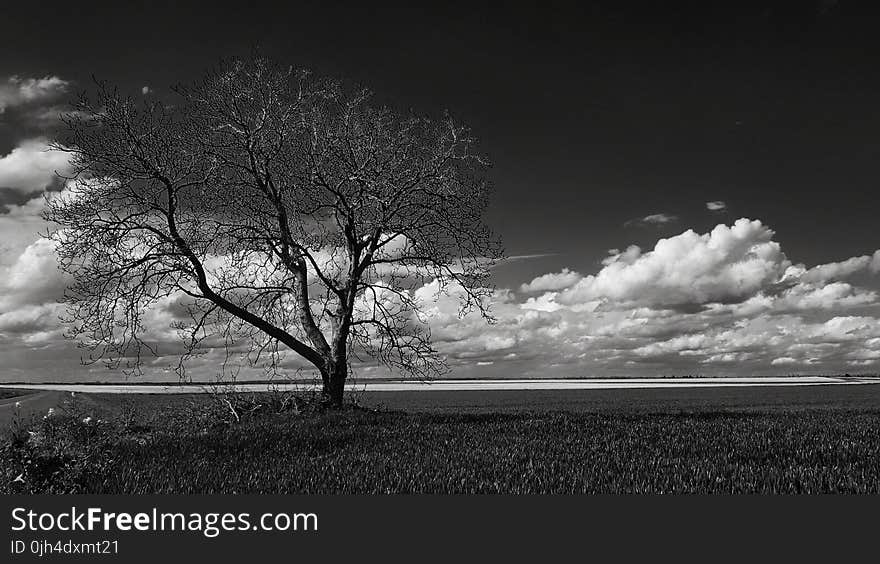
{"left": 502, "top": 219, "right": 880, "bottom": 374}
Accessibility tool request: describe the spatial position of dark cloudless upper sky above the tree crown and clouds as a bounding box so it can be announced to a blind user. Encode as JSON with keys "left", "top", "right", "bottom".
{"left": 0, "top": 0, "right": 880, "bottom": 280}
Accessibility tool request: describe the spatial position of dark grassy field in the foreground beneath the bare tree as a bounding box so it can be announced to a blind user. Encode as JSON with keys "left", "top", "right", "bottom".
{"left": 0, "top": 392, "right": 880, "bottom": 493}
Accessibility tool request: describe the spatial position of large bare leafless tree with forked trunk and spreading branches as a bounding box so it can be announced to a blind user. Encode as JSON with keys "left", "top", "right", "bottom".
{"left": 46, "top": 58, "right": 501, "bottom": 405}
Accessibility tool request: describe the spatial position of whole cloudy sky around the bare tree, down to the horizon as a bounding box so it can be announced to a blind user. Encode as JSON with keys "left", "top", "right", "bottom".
{"left": 0, "top": 0, "right": 880, "bottom": 381}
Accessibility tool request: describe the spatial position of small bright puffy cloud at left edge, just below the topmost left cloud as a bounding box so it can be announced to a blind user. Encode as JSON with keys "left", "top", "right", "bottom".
{"left": 0, "top": 137, "right": 70, "bottom": 194}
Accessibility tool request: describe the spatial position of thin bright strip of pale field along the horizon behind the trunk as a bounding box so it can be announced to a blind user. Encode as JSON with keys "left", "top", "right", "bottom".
{"left": 8, "top": 376, "right": 880, "bottom": 394}
